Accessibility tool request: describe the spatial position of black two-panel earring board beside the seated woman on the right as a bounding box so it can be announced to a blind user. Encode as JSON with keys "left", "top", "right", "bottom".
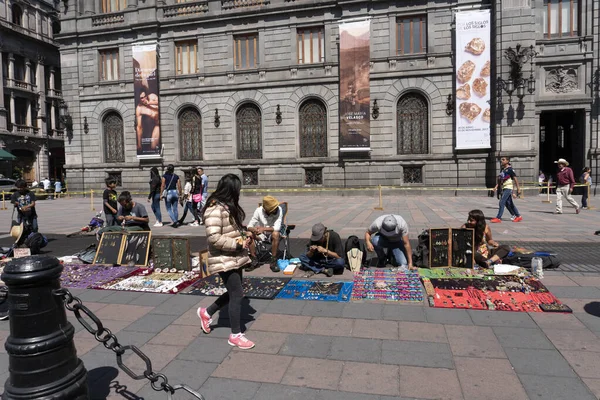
{"left": 429, "top": 228, "right": 475, "bottom": 268}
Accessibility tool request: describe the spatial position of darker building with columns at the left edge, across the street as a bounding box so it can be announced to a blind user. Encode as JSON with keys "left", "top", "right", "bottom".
{"left": 0, "top": 0, "right": 65, "bottom": 182}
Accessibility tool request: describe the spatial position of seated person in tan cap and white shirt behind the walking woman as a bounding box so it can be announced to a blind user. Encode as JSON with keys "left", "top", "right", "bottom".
{"left": 248, "top": 196, "right": 283, "bottom": 272}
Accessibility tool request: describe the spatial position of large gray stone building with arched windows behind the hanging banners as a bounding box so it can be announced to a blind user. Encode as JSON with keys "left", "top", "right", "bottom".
{"left": 59, "top": 0, "right": 599, "bottom": 189}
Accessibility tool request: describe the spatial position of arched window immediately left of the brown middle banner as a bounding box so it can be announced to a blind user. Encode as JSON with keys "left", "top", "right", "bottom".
{"left": 298, "top": 99, "right": 327, "bottom": 157}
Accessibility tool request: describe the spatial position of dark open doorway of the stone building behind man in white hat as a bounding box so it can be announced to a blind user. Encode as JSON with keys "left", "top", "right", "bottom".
{"left": 539, "top": 110, "right": 585, "bottom": 182}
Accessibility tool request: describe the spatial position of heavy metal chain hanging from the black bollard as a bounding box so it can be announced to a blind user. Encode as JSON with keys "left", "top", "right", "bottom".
{"left": 52, "top": 288, "right": 205, "bottom": 400}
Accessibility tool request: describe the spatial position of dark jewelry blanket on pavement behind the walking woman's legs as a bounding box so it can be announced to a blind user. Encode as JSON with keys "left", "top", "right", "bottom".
{"left": 184, "top": 274, "right": 292, "bottom": 299}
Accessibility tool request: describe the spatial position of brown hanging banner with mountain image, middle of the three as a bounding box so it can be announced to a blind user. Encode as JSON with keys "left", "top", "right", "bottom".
{"left": 340, "top": 20, "right": 371, "bottom": 151}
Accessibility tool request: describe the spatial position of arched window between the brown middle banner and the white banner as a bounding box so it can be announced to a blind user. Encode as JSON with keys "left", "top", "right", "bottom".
{"left": 397, "top": 93, "right": 429, "bottom": 154}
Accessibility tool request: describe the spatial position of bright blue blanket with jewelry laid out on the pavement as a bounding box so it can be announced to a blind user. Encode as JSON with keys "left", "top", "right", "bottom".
{"left": 277, "top": 279, "right": 353, "bottom": 303}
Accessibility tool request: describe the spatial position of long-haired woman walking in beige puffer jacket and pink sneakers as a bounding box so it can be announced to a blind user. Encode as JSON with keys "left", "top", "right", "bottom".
{"left": 197, "top": 174, "right": 254, "bottom": 350}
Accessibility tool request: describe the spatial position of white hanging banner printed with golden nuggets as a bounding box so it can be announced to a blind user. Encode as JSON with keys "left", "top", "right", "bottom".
{"left": 455, "top": 10, "right": 491, "bottom": 150}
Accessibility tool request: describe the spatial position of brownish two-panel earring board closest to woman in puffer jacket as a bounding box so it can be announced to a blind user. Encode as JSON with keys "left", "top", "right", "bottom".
{"left": 152, "top": 237, "right": 192, "bottom": 271}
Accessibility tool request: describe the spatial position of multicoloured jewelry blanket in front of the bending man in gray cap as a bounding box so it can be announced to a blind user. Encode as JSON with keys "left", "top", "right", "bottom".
{"left": 352, "top": 269, "right": 423, "bottom": 302}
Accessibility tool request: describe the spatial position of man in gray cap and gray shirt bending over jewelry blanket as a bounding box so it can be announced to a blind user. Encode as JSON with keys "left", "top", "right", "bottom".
{"left": 365, "top": 214, "right": 413, "bottom": 269}
